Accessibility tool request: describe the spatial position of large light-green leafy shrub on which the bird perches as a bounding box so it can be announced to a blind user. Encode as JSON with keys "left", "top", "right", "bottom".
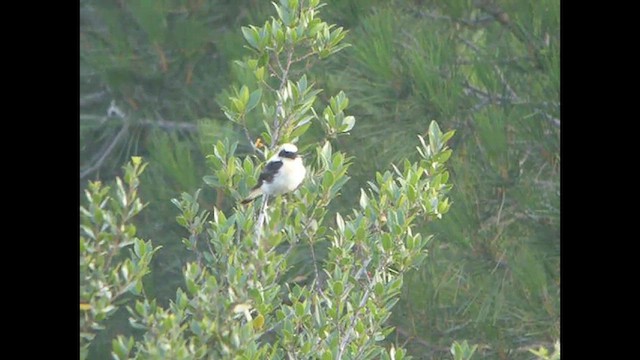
{"left": 106, "top": 1, "right": 453, "bottom": 359}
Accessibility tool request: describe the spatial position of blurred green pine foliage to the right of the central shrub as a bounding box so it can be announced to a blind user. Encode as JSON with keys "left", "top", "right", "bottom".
{"left": 316, "top": 0, "right": 560, "bottom": 358}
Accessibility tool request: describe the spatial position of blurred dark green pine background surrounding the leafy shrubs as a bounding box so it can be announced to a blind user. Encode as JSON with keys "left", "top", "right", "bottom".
{"left": 80, "top": 0, "right": 560, "bottom": 359}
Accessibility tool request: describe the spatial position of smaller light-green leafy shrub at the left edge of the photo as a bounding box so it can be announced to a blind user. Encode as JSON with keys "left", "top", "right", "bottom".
{"left": 80, "top": 157, "right": 158, "bottom": 358}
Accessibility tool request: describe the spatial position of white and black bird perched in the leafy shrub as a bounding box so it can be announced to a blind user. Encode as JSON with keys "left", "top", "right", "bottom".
{"left": 242, "top": 144, "right": 307, "bottom": 204}
